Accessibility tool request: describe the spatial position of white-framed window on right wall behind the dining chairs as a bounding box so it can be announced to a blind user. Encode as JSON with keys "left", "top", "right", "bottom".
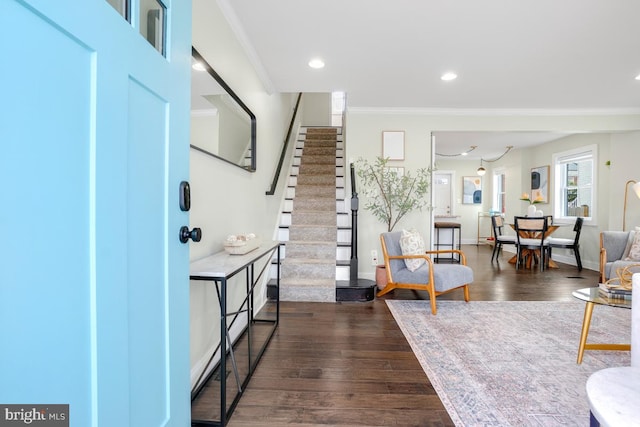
{"left": 553, "top": 145, "right": 598, "bottom": 220}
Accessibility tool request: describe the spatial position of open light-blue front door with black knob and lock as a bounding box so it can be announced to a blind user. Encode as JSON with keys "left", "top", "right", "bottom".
{"left": 0, "top": 0, "right": 191, "bottom": 427}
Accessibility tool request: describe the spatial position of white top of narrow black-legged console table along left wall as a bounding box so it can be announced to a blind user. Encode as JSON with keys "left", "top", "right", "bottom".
{"left": 189, "top": 241, "right": 281, "bottom": 279}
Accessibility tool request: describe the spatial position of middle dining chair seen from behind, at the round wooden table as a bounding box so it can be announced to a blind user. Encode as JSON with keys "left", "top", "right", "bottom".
{"left": 513, "top": 216, "right": 548, "bottom": 271}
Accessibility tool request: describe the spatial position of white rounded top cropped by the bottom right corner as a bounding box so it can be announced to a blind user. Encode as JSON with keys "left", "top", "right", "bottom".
{"left": 587, "top": 366, "right": 640, "bottom": 427}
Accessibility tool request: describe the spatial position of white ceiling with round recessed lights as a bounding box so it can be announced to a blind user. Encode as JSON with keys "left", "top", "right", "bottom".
{"left": 208, "top": 0, "right": 640, "bottom": 156}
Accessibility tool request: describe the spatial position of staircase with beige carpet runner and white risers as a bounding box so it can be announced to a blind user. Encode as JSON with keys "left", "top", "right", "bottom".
{"left": 269, "top": 127, "right": 375, "bottom": 302}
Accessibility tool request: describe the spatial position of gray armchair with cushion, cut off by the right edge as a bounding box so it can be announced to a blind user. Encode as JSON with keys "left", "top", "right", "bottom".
{"left": 600, "top": 231, "right": 640, "bottom": 283}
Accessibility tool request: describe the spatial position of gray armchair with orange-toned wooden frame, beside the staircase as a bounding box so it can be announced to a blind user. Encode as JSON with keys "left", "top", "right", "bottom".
{"left": 378, "top": 231, "right": 473, "bottom": 314}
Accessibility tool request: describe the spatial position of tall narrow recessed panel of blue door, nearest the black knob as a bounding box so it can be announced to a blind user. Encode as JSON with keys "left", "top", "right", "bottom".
{"left": 127, "top": 80, "right": 170, "bottom": 426}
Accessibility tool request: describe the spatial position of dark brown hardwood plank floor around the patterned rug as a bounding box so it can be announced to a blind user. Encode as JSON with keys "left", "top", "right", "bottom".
{"left": 196, "top": 245, "right": 598, "bottom": 427}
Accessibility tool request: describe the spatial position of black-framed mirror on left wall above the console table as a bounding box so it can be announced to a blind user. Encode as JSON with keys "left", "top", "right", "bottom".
{"left": 190, "top": 47, "right": 256, "bottom": 172}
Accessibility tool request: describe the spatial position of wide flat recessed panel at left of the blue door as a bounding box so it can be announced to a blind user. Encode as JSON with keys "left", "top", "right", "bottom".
{"left": 0, "top": 1, "right": 94, "bottom": 420}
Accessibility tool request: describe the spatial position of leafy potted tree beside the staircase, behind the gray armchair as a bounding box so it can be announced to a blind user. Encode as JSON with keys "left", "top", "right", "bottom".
{"left": 355, "top": 157, "right": 431, "bottom": 289}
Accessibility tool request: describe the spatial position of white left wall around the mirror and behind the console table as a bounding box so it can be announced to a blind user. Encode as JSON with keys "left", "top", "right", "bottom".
{"left": 190, "top": 0, "right": 295, "bottom": 392}
